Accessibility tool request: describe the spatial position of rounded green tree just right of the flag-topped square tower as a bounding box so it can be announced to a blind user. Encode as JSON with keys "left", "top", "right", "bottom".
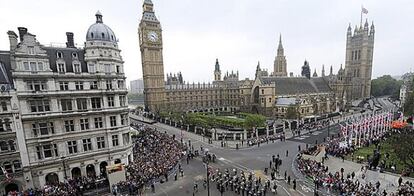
{"left": 371, "top": 75, "right": 402, "bottom": 98}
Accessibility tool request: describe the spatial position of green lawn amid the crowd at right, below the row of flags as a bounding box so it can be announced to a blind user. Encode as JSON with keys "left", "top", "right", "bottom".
{"left": 346, "top": 141, "right": 414, "bottom": 177}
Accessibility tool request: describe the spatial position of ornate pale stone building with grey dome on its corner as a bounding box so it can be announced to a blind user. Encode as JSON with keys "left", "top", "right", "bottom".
{"left": 0, "top": 12, "right": 133, "bottom": 190}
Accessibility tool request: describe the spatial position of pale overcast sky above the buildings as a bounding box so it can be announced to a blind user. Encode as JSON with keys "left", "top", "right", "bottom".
{"left": 0, "top": 0, "right": 414, "bottom": 83}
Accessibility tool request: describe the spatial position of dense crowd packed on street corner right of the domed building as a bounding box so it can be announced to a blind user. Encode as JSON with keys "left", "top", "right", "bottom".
{"left": 114, "top": 125, "right": 186, "bottom": 195}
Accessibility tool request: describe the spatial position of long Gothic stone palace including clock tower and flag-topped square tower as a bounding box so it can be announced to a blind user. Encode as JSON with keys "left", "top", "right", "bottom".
{"left": 138, "top": 0, "right": 375, "bottom": 118}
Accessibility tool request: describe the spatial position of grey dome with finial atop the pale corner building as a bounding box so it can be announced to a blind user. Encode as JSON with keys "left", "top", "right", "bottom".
{"left": 86, "top": 11, "right": 117, "bottom": 43}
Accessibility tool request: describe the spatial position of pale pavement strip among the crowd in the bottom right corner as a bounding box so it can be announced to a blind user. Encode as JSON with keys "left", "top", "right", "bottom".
{"left": 324, "top": 156, "right": 414, "bottom": 193}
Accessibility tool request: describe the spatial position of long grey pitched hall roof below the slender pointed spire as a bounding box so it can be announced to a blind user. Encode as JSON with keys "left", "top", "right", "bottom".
{"left": 260, "top": 76, "right": 333, "bottom": 95}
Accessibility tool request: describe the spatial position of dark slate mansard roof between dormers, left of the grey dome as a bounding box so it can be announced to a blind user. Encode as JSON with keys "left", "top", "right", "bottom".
{"left": 44, "top": 47, "right": 88, "bottom": 72}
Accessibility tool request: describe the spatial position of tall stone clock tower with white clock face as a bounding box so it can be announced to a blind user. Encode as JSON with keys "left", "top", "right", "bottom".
{"left": 138, "top": 0, "right": 165, "bottom": 113}
